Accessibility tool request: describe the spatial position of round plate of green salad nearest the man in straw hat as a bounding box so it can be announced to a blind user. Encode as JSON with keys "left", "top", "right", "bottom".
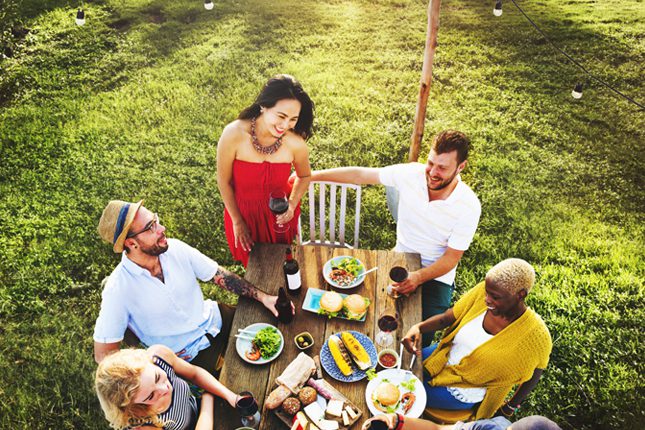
{"left": 235, "top": 323, "right": 284, "bottom": 364}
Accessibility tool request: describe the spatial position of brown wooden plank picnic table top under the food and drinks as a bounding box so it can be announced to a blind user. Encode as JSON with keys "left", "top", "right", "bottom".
{"left": 215, "top": 244, "right": 422, "bottom": 430}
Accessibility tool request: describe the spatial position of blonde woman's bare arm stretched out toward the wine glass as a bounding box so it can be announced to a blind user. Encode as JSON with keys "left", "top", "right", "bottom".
{"left": 148, "top": 345, "right": 237, "bottom": 407}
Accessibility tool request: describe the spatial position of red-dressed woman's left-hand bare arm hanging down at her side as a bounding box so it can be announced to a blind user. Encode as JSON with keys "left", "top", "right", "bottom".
{"left": 217, "top": 124, "right": 253, "bottom": 251}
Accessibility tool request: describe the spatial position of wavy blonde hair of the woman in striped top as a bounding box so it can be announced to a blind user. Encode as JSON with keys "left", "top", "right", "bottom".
{"left": 94, "top": 349, "right": 164, "bottom": 430}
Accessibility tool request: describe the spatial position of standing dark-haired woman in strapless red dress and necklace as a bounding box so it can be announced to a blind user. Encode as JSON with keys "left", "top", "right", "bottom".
{"left": 217, "top": 75, "right": 314, "bottom": 267}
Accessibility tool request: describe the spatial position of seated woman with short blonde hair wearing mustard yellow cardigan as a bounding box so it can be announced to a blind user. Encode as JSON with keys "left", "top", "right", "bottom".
{"left": 403, "top": 258, "right": 552, "bottom": 422}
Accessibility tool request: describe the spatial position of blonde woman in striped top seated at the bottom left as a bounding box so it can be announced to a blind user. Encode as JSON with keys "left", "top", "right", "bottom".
{"left": 95, "top": 345, "right": 237, "bottom": 430}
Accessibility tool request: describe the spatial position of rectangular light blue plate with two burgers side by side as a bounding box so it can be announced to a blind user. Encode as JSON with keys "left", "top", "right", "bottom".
{"left": 302, "top": 288, "right": 372, "bottom": 321}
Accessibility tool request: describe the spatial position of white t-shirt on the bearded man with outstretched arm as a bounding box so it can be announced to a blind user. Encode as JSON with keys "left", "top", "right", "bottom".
{"left": 379, "top": 163, "right": 481, "bottom": 285}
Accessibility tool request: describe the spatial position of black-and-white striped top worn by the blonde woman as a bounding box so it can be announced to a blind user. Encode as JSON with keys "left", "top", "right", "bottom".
{"left": 132, "top": 355, "right": 197, "bottom": 430}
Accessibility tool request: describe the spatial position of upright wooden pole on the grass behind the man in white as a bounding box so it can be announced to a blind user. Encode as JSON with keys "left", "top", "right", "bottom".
{"left": 408, "top": 0, "right": 441, "bottom": 161}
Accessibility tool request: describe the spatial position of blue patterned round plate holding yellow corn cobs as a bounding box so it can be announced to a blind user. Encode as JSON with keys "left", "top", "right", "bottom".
{"left": 320, "top": 330, "right": 376, "bottom": 382}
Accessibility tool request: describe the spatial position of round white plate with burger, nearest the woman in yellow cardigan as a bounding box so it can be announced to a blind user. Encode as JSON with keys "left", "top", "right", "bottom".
{"left": 365, "top": 369, "right": 426, "bottom": 418}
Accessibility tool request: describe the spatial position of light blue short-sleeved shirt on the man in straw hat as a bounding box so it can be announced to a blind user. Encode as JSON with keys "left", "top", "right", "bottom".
{"left": 94, "top": 239, "right": 222, "bottom": 359}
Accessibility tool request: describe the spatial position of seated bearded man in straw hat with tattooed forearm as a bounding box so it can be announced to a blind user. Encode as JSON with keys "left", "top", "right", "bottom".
{"left": 94, "top": 200, "right": 290, "bottom": 373}
